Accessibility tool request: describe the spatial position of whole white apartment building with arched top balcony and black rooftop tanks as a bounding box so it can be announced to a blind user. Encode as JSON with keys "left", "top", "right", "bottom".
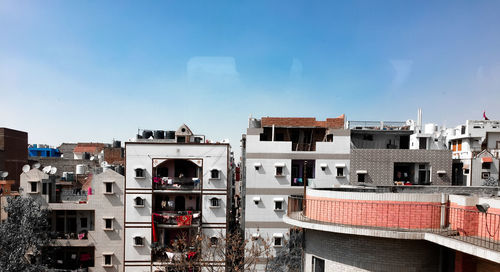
{"left": 124, "top": 125, "right": 231, "bottom": 272}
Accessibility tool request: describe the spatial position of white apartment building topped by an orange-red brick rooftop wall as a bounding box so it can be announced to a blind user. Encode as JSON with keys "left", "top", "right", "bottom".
{"left": 242, "top": 115, "right": 350, "bottom": 264}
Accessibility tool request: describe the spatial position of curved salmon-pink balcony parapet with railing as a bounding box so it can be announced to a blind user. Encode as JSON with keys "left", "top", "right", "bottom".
{"left": 287, "top": 196, "right": 500, "bottom": 251}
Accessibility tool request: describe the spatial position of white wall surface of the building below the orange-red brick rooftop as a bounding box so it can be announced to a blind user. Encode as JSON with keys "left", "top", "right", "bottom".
{"left": 243, "top": 117, "right": 350, "bottom": 268}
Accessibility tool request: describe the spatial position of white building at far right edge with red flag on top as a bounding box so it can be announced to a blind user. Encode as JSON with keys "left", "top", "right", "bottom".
{"left": 446, "top": 120, "right": 500, "bottom": 186}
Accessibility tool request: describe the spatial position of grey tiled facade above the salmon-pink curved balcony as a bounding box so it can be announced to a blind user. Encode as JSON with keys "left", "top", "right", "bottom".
{"left": 350, "top": 149, "right": 452, "bottom": 185}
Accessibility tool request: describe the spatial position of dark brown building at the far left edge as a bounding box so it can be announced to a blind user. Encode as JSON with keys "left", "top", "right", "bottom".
{"left": 0, "top": 128, "right": 28, "bottom": 190}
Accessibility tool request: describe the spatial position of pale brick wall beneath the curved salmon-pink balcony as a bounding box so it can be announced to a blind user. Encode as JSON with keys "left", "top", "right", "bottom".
{"left": 304, "top": 229, "right": 439, "bottom": 272}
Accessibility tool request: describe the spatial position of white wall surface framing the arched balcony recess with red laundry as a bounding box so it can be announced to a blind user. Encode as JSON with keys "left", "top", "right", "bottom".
{"left": 124, "top": 140, "right": 230, "bottom": 272}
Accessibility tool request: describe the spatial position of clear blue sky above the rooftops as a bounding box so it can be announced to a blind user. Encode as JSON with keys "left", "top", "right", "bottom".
{"left": 0, "top": 0, "right": 500, "bottom": 157}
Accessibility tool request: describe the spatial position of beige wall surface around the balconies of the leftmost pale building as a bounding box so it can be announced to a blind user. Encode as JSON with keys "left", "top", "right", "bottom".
{"left": 20, "top": 168, "right": 125, "bottom": 272}
